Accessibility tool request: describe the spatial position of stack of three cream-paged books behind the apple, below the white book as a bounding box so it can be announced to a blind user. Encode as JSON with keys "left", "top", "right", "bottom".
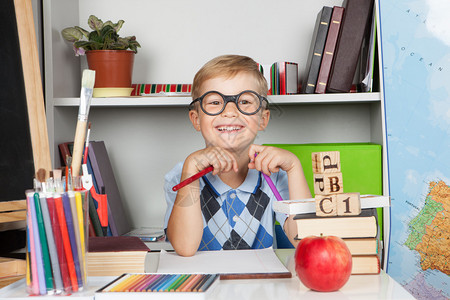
{"left": 294, "top": 208, "right": 381, "bottom": 274}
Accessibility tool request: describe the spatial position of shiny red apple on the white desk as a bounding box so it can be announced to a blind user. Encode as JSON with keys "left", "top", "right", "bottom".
{"left": 295, "top": 236, "right": 352, "bottom": 292}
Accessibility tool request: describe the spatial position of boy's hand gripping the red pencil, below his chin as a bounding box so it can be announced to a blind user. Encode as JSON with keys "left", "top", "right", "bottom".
{"left": 185, "top": 147, "right": 238, "bottom": 175}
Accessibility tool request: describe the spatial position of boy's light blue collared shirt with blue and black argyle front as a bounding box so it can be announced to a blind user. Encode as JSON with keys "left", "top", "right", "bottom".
{"left": 164, "top": 162, "right": 289, "bottom": 250}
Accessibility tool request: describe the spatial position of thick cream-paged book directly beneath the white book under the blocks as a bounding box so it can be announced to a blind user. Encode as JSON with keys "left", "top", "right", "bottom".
{"left": 294, "top": 208, "right": 379, "bottom": 239}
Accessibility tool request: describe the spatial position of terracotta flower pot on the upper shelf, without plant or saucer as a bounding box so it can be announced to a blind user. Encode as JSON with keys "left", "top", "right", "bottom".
{"left": 86, "top": 50, "right": 135, "bottom": 88}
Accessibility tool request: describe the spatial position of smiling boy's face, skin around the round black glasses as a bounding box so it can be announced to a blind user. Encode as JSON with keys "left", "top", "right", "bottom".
{"left": 189, "top": 72, "right": 270, "bottom": 152}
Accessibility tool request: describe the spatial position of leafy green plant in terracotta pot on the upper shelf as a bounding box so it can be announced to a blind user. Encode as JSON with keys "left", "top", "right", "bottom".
{"left": 61, "top": 15, "right": 141, "bottom": 97}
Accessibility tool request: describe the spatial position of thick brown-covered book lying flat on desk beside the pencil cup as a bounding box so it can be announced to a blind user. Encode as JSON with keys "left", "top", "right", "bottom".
{"left": 86, "top": 236, "right": 150, "bottom": 276}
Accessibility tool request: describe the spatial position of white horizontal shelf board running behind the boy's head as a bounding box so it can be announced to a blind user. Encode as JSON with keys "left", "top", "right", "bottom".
{"left": 54, "top": 93, "right": 381, "bottom": 107}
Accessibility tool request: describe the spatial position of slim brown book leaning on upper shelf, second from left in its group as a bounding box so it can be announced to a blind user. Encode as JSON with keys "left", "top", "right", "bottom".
{"left": 314, "top": 6, "right": 344, "bottom": 94}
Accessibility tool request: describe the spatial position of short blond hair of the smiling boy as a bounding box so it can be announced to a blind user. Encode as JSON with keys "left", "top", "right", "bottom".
{"left": 192, "top": 55, "right": 267, "bottom": 99}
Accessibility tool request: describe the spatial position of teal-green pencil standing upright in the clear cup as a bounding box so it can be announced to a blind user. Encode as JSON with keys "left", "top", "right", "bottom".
{"left": 34, "top": 193, "right": 53, "bottom": 291}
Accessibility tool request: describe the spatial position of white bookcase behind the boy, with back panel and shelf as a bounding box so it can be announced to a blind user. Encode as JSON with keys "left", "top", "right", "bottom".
{"left": 43, "top": 0, "right": 387, "bottom": 241}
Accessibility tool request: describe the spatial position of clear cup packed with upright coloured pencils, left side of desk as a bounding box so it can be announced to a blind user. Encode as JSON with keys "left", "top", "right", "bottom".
{"left": 25, "top": 189, "right": 89, "bottom": 295}
